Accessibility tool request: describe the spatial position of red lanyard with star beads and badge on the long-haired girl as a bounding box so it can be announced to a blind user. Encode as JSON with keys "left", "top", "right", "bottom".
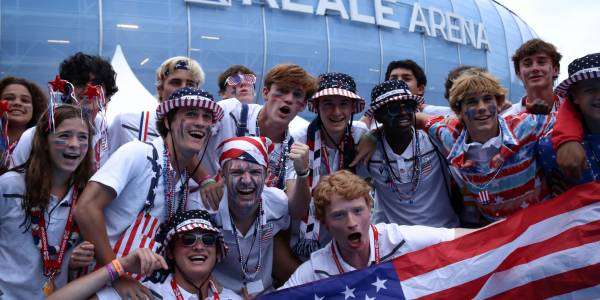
{"left": 31, "top": 187, "right": 79, "bottom": 296}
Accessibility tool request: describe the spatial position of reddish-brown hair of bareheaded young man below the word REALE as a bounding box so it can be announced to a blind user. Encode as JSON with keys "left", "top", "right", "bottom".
{"left": 264, "top": 64, "right": 317, "bottom": 100}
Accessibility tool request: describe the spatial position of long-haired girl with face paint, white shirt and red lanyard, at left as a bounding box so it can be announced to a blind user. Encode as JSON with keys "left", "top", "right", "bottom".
{"left": 0, "top": 105, "right": 93, "bottom": 299}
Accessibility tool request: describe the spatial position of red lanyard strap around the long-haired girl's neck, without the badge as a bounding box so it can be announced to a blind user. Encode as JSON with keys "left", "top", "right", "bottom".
{"left": 38, "top": 188, "right": 77, "bottom": 279}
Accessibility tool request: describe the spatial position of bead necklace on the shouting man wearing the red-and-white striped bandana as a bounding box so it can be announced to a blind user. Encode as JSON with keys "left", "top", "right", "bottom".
{"left": 229, "top": 200, "right": 264, "bottom": 285}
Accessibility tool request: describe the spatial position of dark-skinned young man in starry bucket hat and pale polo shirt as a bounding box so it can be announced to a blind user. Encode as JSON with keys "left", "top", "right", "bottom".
{"left": 366, "top": 80, "right": 458, "bottom": 227}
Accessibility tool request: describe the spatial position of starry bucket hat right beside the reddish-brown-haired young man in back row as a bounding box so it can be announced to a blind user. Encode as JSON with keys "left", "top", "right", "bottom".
{"left": 308, "top": 73, "right": 365, "bottom": 114}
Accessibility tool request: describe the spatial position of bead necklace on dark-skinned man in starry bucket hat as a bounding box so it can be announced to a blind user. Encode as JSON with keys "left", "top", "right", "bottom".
{"left": 381, "top": 129, "right": 421, "bottom": 203}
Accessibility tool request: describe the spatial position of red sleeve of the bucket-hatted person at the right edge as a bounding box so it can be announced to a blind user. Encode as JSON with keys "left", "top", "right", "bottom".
{"left": 552, "top": 99, "right": 583, "bottom": 151}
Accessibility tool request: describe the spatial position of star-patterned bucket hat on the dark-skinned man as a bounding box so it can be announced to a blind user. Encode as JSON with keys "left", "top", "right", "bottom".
{"left": 365, "top": 80, "right": 423, "bottom": 117}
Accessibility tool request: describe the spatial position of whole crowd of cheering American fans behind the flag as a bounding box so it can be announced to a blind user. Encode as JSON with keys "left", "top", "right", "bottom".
{"left": 0, "top": 39, "right": 600, "bottom": 299}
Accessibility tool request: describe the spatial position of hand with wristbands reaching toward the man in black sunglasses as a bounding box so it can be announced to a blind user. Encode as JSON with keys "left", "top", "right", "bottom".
{"left": 119, "top": 248, "right": 169, "bottom": 276}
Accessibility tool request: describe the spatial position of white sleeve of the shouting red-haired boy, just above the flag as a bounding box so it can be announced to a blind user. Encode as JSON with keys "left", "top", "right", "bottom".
{"left": 388, "top": 224, "right": 456, "bottom": 251}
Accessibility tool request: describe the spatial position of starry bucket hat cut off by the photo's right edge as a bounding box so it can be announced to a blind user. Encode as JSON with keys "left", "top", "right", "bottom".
{"left": 554, "top": 53, "right": 600, "bottom": 96}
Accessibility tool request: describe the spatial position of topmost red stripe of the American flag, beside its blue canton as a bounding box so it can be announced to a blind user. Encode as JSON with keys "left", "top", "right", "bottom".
{"left": 393, "top": 182, "right": 600, "bottom": 281}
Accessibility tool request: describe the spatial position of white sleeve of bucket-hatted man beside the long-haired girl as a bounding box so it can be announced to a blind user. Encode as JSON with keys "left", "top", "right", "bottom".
{"left": 90, "top": 141, "right": 151, "bottom": 197}
